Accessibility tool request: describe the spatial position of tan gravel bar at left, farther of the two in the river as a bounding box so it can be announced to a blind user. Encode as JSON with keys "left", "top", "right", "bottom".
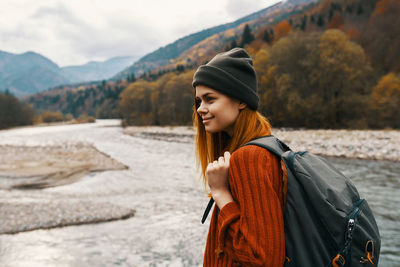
{"left": 0, "top": 143, "right": 128, "bottom": 189}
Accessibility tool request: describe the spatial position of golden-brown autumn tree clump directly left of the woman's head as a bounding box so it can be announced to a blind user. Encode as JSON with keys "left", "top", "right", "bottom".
{"left": 119, "top": 70, "right": 194, "bottom": 125}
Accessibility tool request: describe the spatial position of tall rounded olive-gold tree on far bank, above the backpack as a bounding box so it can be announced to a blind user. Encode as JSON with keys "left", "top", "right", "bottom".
{"left": 313, "top": 30, "right": 372, "bottom": 128}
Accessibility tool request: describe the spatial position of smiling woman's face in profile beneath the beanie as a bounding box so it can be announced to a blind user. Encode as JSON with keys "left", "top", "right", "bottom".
{"left": 196, "top": 85, "right": 246, "bottom": 136}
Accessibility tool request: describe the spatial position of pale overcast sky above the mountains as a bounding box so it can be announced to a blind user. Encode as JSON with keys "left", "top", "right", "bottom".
{"left": 0, "top": 0, "right": 279, "bottom": 66}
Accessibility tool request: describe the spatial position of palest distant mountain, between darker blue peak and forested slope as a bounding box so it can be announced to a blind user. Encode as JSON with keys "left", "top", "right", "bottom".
{"left": 62, "top": 56, "right": 138, "bottom": 83}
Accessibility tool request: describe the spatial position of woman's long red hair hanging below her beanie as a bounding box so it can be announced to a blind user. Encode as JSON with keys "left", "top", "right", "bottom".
{"left": 193, "top": 100, "right": 271, "bottom": 185}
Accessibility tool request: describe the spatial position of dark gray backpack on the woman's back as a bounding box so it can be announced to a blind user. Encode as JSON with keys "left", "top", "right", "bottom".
{"left": 246, "top": 136, "right": 381, "bottom": 267}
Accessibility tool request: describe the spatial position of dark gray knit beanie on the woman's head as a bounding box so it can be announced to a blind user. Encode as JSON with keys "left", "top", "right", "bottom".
{"left": 192, "top": 48, "right": 258, "bottom": 110}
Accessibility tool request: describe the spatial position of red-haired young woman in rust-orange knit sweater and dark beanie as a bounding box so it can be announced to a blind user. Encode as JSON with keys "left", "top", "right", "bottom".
{"left": 193, "top": 48, "right": 285, "bottom": 267}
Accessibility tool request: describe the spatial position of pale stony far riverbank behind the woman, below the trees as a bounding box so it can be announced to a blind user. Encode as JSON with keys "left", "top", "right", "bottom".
{"left": 123, "top": 126, "right": 400, "bottom": 162}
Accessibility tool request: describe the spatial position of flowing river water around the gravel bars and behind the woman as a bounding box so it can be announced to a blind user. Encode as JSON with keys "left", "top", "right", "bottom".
{"left": 0, "top": 120, "right": 400, "bottom": 267}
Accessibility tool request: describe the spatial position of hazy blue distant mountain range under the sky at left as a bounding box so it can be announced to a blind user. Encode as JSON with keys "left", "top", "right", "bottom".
{"left": 0, "top": 51, "right": 137, "bottom": 96}
